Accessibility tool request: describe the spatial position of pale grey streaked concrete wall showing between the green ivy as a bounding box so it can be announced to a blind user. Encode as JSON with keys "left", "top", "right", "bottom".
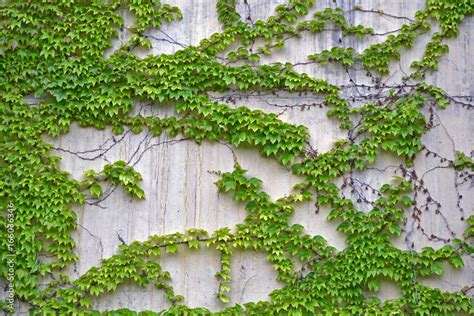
{"left": 12, "top": 0, "right": 474, "bottom": 310}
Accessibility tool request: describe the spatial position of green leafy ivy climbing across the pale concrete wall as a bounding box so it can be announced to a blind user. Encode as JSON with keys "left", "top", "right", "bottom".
{"left": 0, "top": 0, "right": 474, "bottom": 315}
